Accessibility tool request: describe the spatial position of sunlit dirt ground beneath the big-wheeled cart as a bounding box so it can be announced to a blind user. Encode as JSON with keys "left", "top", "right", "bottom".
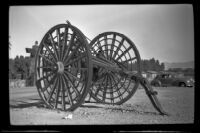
{"left": 9, "top": 87, "right": 194, "bottom": 125}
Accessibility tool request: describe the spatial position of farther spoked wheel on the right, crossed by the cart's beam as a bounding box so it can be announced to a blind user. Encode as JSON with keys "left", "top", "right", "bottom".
{"left": 90, "top": 32, "right": 141, "bottom": 105}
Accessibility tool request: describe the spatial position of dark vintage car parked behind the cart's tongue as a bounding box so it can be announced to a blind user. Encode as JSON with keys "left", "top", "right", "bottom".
{"left": 151, "top": 73, "right": 194, "bottom": 87}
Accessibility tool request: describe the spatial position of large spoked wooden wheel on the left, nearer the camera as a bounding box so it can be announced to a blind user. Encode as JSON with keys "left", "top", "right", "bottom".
{"left": 35, "top": 23, "right": 92, "bottom": 111}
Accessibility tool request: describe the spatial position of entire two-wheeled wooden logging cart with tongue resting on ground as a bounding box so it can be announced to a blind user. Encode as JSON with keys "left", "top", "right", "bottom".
{"left": 35, "top": 22, "right": 169, "bottom": 114}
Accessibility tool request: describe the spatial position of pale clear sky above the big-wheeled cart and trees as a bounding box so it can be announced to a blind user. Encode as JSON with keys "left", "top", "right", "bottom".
{"left": 9, "top": 4, "right": 194, "bottom": 62}
